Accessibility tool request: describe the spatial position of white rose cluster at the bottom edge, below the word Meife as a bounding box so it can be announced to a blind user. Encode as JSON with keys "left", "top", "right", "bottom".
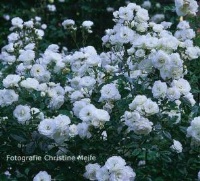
{"left": 84, "top": 156, "right": 136, "bottom": 181}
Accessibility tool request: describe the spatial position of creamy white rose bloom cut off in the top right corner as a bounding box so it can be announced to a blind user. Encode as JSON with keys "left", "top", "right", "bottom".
{"left": 175, "top": 0, "right": 198, "bottom": 16}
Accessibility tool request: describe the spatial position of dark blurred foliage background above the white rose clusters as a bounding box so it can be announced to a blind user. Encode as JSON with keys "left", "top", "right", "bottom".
{"left": 0, "top": 0, "right": 176, "bottom": 51}
